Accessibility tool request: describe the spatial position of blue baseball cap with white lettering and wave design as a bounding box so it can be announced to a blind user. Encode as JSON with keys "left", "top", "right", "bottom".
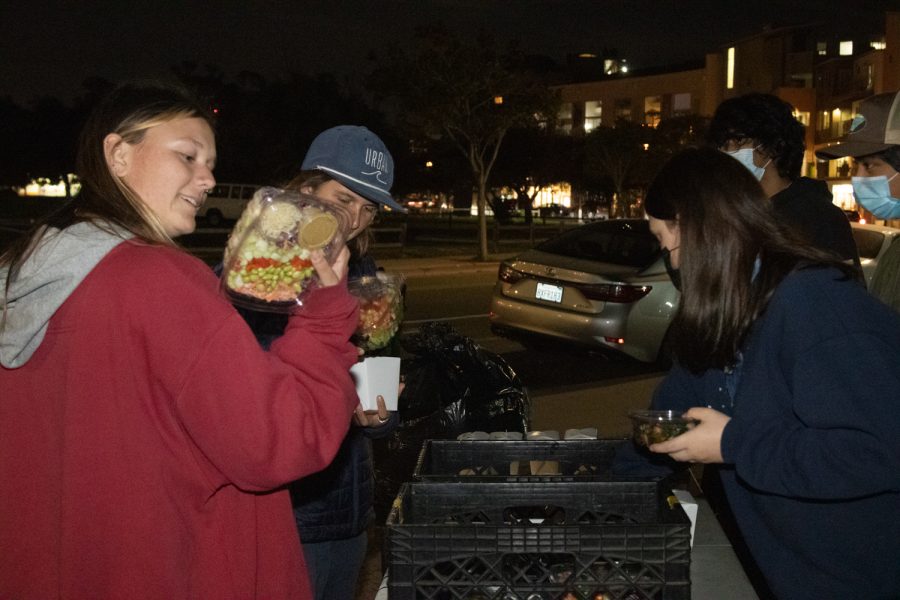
{"left": 300, "top": 125, "right": 406, "bottom": 212}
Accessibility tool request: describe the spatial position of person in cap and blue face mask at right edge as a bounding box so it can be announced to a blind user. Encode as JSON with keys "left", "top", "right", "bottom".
{"left": 816, "top": 92, "right": 900, "bottom": 310}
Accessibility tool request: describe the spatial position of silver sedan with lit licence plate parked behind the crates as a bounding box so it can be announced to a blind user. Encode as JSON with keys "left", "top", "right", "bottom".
{"left": 489, "top": 219, "right": 680, "bottom": 362}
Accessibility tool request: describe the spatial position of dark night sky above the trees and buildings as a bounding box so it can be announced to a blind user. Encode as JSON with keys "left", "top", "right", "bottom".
{"left": 0, "top": 0, "right": 898, "bottom": 105}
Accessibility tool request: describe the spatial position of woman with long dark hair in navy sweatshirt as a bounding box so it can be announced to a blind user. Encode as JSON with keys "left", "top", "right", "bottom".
{"left": 646, "top": 149, "right": 900, "bottom": 599}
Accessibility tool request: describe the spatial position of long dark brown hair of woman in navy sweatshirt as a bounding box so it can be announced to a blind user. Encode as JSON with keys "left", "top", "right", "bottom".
{"left": 645, "top": 148, "right": 855, "bottom": 373}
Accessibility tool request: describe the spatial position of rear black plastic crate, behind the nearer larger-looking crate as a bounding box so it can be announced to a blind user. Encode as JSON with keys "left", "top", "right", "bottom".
{"left": 413, "top": 439, "right": 629, "bottom": 482}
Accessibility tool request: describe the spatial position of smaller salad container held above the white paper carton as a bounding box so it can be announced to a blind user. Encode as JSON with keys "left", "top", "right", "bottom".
{"left": 347, "top": 271, "right": 406, "bottom": 352}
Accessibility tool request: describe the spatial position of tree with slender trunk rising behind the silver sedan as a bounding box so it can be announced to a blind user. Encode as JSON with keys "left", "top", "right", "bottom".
{"left": 370, "top": 28, "right": 556, "bottom": 260}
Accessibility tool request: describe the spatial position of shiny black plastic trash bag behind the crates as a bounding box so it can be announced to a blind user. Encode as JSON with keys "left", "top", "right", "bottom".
{"left": 373, "top": 322, "right": 531, "bottom": 522}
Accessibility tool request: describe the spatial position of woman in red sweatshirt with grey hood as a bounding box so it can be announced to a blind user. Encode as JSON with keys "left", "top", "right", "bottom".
{"left": 0, "top": 83, "right": 358, "bottom": 599}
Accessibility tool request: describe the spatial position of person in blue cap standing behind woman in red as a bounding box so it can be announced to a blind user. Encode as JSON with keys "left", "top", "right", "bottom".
{"left": 221, "top": 125, "right": 406, "bottom": 600}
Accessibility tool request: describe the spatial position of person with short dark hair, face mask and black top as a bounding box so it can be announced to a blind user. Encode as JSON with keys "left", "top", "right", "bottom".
{"left": 707, "top": 93, "right": 861, "bottom": 272}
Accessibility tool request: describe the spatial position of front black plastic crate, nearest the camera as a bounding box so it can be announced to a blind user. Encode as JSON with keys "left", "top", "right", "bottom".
{"left": 384, "top": 481, "right": 691, "bottom": 600}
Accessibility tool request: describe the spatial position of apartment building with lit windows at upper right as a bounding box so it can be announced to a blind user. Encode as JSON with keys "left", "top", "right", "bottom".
{"left": 556, "top": 11, "right": 900, "bottom": 204}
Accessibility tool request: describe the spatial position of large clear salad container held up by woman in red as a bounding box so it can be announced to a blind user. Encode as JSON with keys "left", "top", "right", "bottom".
{"left": 221, "top": 187, "right": 349, "bottom": 313}
